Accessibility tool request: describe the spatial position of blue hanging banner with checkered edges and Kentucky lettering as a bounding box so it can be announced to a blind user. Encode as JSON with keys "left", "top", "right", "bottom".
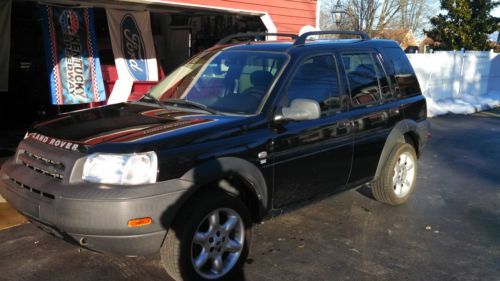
{"left": 40, "top": 5, "right": 106, "bottom": 105}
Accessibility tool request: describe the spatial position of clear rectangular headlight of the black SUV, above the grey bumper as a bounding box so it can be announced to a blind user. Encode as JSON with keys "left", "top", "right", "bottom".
{"left": 82, "top": 151, "right": 158, "bottom": 185}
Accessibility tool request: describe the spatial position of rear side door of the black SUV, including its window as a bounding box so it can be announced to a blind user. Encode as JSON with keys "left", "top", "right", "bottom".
{"left": 340, "top": 49, "right": 399, "bottom": 185}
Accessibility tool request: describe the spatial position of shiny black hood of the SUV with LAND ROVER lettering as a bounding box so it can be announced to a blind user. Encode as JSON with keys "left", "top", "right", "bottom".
{"left": 27, "top": 103, "right": 246, "bottom": 150}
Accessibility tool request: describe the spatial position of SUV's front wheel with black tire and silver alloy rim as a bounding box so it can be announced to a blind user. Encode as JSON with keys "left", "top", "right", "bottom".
{"left": 160, "top": 190, "right": 252, "bottom": 281}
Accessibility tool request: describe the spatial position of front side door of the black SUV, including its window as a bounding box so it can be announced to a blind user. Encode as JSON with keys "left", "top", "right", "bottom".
{"left": 273, "top": 54, "right": 353, "bottom": 208}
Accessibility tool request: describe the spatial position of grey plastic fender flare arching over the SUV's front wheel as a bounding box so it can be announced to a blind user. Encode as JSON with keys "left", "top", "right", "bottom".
{"left": 180, "top": 157, "right": 269, "bottom": 218}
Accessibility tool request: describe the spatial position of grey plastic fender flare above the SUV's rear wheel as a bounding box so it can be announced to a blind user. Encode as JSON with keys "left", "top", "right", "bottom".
{"left": 374, "top": 119, "right": 420, "bottom": 180}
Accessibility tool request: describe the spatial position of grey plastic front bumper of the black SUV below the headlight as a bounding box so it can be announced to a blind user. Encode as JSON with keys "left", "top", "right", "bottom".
{"left": 0, "top": 143, "right": 192, "bottom": 256}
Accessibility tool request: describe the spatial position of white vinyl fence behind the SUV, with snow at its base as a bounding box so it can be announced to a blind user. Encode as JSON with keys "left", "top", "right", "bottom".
{"left": 408, "top": 51, "right": 500, "bottom": 116}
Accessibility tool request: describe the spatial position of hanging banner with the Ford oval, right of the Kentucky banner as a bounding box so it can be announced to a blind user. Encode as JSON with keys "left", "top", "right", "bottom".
{"left": 106, "top": 9, "right": 158, "bottom": 104}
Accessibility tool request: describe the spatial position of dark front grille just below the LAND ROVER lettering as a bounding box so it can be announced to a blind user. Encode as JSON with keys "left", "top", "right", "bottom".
{"left": 18, "top": 151, "right": 65, "bottom": 180}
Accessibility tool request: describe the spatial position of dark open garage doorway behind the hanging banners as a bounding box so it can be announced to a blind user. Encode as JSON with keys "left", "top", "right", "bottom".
{"left": 0, "top": 1, "right": 266, "bottom": 157}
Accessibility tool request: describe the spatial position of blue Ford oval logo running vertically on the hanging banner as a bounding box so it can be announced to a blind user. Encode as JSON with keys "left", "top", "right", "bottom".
{"left": 120, "top": 14, "right": 148, "bottom": 81}
